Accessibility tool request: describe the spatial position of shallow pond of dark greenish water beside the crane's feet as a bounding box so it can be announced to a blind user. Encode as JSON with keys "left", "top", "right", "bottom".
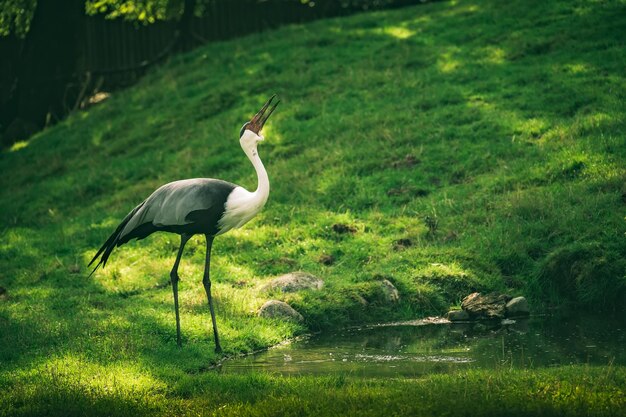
{"left": 221, "top": 316, "right": 626, "bottom": 377}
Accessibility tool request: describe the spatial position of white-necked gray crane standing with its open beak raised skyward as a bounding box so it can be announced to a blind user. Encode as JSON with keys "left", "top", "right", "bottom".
{"left": 89, "top": 95, "right": 280, "bottom": 352}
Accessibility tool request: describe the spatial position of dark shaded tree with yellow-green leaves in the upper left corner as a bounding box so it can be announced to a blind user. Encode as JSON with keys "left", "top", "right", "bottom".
{"left": 0, "top": 0, "right": 196, "bottom": 145}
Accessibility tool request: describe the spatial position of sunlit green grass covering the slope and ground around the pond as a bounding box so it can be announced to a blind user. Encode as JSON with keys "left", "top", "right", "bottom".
{"left": 0, "top": 0, "right": 626, "bottom": 415}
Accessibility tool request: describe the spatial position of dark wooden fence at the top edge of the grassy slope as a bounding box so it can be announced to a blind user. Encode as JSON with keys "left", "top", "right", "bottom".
{"left": 78, "top": 0, "right": 424, "bottom": 87}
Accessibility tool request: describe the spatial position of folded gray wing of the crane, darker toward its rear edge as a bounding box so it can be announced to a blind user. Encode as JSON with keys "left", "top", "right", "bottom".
{"left": 118, "top": 178, "right": 236, "bottom": 242}
